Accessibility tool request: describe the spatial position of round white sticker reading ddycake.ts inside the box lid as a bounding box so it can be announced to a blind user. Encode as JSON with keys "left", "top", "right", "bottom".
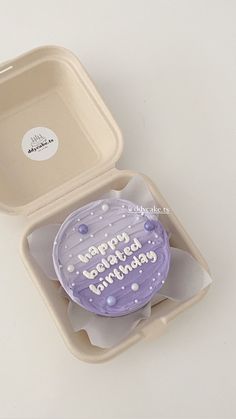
{"left": 21, "top": 127, "right": 58, "bottom": 161}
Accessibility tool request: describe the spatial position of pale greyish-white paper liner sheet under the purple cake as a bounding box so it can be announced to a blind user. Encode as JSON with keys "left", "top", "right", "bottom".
{"left": 28, "top": 175, "right": 212, "bottom": 348}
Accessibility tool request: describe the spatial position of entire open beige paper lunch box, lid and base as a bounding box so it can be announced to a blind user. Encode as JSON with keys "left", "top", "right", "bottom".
{"left": 0, "top": 46, "right": 208, "bottom": 362}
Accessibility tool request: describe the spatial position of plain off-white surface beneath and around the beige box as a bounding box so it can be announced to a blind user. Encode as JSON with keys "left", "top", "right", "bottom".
{"left": 0, "top": 0, "right": 236, "bottom": 419}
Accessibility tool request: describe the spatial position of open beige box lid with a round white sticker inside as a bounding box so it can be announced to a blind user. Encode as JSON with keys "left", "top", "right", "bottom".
{"left": 0, "top": 47, "right": 123, "bottom": 214}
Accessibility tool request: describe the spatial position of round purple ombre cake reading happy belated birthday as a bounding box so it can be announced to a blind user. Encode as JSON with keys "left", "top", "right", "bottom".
{"left": 53, "top": 198, "right": 170, "bottom": 317}
